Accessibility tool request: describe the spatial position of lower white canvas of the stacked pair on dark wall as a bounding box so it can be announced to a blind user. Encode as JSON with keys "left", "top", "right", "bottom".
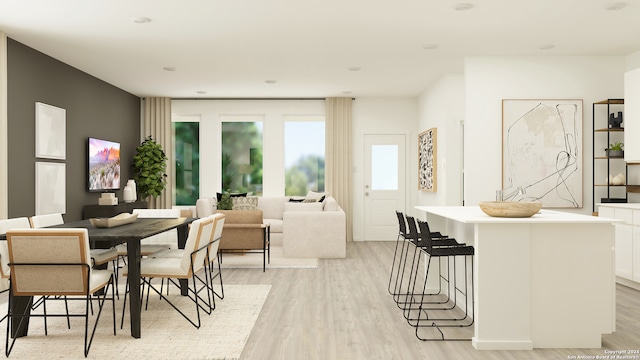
{"left": 36, "top": 161, "right": 66, "bottom": 215}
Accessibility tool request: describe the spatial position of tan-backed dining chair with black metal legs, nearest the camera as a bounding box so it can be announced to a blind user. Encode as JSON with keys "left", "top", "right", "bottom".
{"left": 5, "top": 228, "right": 116, "bottom": 357}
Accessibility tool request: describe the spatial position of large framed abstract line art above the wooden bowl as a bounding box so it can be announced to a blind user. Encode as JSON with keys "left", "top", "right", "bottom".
{"left": 502, "top": 99, "right": 583, "bottom": 208}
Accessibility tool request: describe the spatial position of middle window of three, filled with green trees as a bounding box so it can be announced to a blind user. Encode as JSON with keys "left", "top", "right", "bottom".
{"left": 221, "top": 116, "right": 262, "bottom": 195}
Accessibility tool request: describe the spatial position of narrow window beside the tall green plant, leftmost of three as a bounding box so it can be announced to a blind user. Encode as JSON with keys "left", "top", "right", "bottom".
{"left": 172, "top": 118, "right": 200, "bottom": 205}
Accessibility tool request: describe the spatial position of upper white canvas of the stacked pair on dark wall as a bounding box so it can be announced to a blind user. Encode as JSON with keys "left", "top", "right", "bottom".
{"left": 36, "top": 102, "right": 67, "bottom": 160}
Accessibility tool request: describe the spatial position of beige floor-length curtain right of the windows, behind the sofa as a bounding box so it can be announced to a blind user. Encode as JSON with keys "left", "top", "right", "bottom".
{"left": 325, "top": 97, "right": 353, "bottom": 241}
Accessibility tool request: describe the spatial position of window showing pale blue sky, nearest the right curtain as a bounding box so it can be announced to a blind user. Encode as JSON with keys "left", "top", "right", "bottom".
{"left": 284, "top": 116, "right": 325, "bottom": 196}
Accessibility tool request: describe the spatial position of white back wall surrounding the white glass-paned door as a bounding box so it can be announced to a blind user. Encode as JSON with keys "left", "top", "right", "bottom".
{"left": 353, "top": 98, "right": 418, "bottom": 241}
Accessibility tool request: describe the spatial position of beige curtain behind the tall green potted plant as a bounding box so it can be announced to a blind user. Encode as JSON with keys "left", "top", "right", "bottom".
{"left": 140, "top": 97, "right": 174, "bottom": 209}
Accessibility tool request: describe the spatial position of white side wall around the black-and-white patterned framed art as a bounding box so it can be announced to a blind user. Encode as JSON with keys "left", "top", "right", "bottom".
{"left": 418, "top": 74, "right": 465, "bottom": 208}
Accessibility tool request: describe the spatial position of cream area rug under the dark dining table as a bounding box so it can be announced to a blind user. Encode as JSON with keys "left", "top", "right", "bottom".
{"left": 0, "top": 285, "right": 271, "bottom": 360}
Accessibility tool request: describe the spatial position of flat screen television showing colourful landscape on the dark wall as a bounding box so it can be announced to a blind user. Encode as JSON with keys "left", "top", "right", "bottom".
{"left": 88, "top": 137, "right": 120, "bottom": 192}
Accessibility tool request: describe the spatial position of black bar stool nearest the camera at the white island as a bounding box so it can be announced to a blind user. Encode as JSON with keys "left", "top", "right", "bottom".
{"left": 405, "top": 220, "right": 475, "bottom": 341}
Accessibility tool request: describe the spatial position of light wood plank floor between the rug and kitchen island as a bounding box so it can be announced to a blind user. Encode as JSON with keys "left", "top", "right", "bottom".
{"left": 223, "top": 242, "right": 640, "bottom": 360}
